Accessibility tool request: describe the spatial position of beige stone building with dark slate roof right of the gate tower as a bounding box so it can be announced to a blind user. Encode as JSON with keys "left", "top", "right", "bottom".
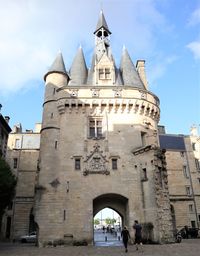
{"left": 160, "top": 126, "right": 200, "bottom": 229}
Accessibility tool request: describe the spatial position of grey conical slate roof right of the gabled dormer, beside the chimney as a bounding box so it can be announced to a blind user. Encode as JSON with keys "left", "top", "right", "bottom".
{"left": 120, "top": 47, "right": 145, "bottom": 89}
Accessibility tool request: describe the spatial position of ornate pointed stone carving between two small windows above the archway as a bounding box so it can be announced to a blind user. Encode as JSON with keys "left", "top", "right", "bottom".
{"left": 83, "top": 143, "right": 110, "bottom": 176}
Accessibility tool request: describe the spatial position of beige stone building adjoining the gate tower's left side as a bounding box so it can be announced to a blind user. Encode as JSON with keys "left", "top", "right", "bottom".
{"left": 1, "top": 124, "right": 41, "bottom": 240}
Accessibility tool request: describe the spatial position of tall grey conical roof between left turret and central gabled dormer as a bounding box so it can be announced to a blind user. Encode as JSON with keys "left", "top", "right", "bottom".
{"left": 69, "top": 47, "right": 88, "bottom": 85}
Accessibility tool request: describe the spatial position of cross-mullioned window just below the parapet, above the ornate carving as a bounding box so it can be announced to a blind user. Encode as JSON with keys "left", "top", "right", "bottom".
{"left": 89, "top": 118, "right": 102, "bottom": 138}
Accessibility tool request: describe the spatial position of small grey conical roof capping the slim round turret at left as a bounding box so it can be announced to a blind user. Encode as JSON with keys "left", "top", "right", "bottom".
{"left": 44, "top": 51, "right": 69, "bottom": 81}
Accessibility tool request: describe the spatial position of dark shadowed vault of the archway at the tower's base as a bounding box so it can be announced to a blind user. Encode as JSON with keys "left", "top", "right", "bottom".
{"left": 93, "top": 193, "right": 129, "bottom": 225}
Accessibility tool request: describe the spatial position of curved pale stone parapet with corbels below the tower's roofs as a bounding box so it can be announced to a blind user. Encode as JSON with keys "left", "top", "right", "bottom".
{"left": 56, "top": 87, "right": 160, "bottom": 122}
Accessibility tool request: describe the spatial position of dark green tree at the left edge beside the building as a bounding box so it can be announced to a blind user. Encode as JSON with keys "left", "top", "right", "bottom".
{"left": 0, "top": 157, "right": 17, "bottom": 226}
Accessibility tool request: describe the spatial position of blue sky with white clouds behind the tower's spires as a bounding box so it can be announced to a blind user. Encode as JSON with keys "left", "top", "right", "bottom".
{"left": 0, "top": 0, "right": 200, "bottom": 134}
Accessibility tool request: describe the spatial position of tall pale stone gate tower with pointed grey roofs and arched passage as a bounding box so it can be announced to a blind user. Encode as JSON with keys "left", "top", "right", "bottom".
{"left": 35, "top": 12, "right": 172, "bottom": 244}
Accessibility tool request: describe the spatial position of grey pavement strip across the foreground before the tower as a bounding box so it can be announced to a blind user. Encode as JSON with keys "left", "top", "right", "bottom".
{"left": 0, "top": 239, "right": 200, "bottom": 256}
